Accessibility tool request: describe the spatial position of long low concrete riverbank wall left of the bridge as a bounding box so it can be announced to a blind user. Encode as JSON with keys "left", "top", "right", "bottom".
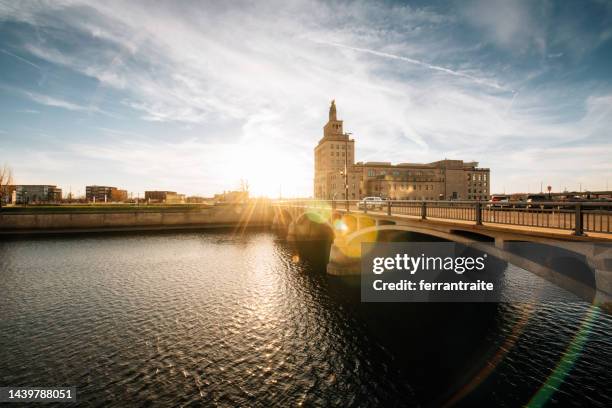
{"left": 0, "top": 202, "right": 274, "bottom": 235}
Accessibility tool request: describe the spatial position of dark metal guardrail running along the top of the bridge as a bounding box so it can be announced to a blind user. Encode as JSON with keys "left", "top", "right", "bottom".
{"left": 274, "top": 200, "right": 612, "bottom": 235}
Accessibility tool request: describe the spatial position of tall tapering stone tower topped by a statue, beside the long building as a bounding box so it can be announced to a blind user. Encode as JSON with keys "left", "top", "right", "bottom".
{"left": 314, "top": 101, "right": 358, "bottom": 200}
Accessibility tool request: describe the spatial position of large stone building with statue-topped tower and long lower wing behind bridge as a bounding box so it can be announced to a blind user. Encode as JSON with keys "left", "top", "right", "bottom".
{"left": 314, "top": 101, "right": 490, "bottom": 200}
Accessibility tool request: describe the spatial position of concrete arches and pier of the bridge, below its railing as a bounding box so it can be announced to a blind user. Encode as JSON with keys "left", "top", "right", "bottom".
{"left": 275, "top": 203, "right": 612, "bottom": 308}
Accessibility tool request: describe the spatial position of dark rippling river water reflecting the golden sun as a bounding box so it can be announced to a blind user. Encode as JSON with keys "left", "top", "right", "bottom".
{"left": 0, "top": 231, "right": 612, "bottom": 407}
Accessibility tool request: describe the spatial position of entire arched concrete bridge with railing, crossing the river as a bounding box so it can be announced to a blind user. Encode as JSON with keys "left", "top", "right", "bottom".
{"left": 273, "top": 200, "right": 612, "bottom": 310}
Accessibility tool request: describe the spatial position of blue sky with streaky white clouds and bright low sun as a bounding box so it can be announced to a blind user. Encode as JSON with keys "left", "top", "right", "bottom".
{"left": 0, "top": 0, "right": 612, "bottom": 197}
